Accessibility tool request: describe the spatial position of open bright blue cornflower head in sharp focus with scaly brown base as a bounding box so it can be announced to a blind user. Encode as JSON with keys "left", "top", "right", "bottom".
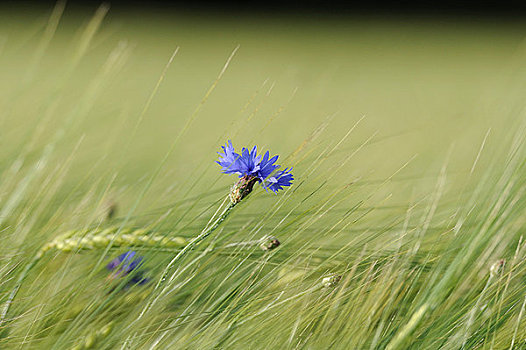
{"left": 216, "top": 140, "right": 294, "bottom": 204}
